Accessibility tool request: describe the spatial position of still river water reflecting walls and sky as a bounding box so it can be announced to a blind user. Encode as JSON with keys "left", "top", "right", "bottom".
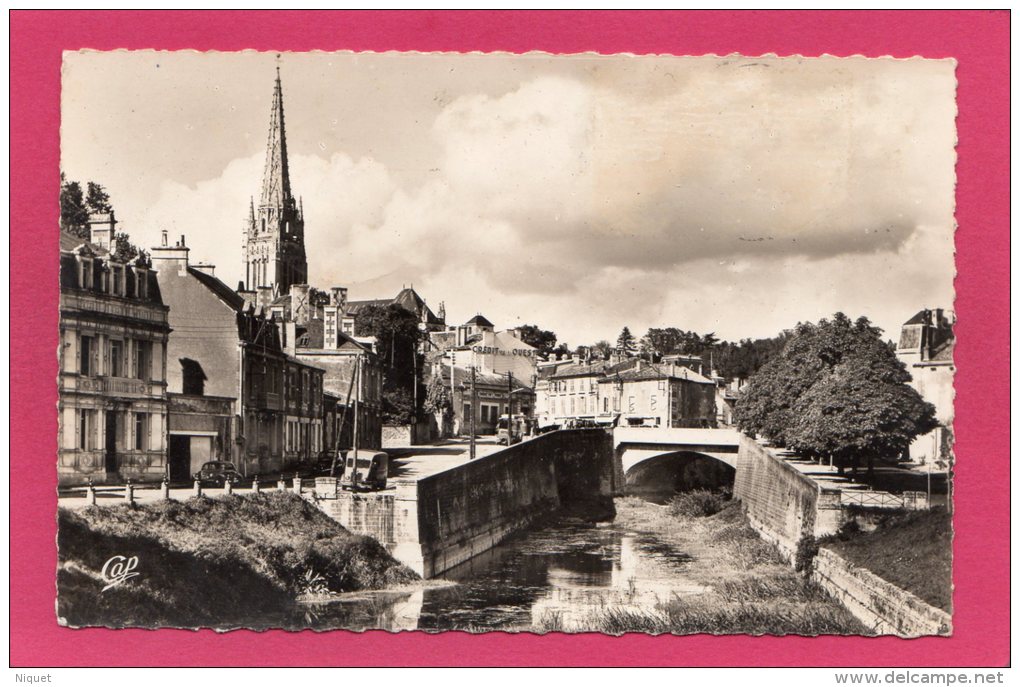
{"left": 295, "top": 513, "right": 704, "bottom": 631}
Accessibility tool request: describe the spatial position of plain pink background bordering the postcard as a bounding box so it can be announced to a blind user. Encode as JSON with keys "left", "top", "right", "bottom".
{"left": 10, "top": 11, "right": 1010, "bottom": 667}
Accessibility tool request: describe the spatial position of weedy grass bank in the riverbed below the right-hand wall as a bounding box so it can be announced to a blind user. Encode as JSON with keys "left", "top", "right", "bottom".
{"left": 538, "top": 498, "right": 866, "bottom": 635}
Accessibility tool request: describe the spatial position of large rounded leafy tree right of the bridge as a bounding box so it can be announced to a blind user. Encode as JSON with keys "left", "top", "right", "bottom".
{"left": 734, "top": 313, "right": 934, "bottom": 468}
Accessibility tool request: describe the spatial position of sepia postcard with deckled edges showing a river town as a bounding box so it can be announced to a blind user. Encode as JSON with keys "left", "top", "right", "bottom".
{"left": 53, "top": 50, "right": 957, "bottom": 637}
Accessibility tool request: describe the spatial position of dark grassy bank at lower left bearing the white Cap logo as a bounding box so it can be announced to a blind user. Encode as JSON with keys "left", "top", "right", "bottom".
{"left": 57, "top": 492, "right": 417, "bottom": 628}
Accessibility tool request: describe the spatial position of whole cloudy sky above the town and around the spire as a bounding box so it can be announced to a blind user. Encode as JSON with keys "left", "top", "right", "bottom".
{"left": 61, "top": 52, "right": 956, "bottom": 346}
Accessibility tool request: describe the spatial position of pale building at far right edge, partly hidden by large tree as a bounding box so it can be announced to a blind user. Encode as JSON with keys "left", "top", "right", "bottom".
{"left": 896, "top": 308, "right": 956, "bottom": 468}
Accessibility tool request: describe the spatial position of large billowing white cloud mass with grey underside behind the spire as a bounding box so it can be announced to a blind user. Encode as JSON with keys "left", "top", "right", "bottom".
{"left": 125, "top": 64, "right": 954, "bottom": 345}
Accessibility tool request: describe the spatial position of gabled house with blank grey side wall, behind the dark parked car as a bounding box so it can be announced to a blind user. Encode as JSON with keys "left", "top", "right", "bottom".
{"left": 152, "top": 232, "right": 323, "bottom": 475}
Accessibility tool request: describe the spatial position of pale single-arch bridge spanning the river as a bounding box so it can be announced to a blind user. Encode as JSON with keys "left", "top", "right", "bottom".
{"left": 613, "top": 427, "right": 741, "bottom": 493}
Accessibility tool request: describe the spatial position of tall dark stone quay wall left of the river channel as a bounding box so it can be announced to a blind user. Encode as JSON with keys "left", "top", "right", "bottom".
{"left": 316, "top": 429, "right": 617, "bottom": 578}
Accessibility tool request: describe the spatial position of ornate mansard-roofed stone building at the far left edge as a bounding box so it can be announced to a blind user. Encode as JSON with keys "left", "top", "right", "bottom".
{"left": 57, "top": 218, "right": 170, "bottom": 483}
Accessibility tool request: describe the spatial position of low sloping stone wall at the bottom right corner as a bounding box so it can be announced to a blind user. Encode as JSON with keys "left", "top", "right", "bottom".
{"left": 811, "top": 548, "right": 953, "bottom": 637}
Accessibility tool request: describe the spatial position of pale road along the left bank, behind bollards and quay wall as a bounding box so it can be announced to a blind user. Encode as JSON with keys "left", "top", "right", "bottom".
{"left": 58, "top": 437, "right": 502, "bottom": 509}
